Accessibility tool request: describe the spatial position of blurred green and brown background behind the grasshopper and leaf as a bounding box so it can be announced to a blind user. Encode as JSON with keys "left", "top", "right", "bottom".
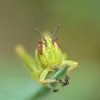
{"left": 0, "top": 0, "right": 100, "bottom": 100}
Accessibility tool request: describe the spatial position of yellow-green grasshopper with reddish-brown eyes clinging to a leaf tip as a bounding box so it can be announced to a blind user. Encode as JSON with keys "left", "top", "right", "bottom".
{"left": 16, "top": 25, "right": 78, "bottom": 92}
